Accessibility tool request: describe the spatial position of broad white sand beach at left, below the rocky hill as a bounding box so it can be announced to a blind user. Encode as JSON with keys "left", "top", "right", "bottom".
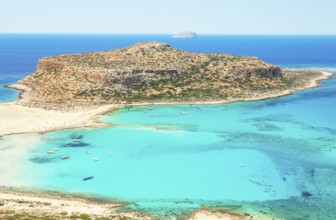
{"left": 0, "top": 102, "right": 114, "bottom": 135}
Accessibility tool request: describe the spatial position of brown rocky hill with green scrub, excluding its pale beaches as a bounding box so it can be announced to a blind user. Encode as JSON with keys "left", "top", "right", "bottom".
{"left": 20, "top": 42, "right": 322, "bottom": 109}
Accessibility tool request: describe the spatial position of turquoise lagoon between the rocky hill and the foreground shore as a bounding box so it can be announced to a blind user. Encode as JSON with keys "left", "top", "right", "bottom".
{"left": 2, "top": 75, "right": 336, "bottom": 219}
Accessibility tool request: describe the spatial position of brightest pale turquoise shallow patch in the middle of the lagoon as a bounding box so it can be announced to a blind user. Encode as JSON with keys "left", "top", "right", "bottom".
{"left": 25, "top": 128, "right": 299, "bottom": 201}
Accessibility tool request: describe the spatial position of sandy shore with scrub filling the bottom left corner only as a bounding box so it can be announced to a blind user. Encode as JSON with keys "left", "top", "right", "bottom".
{"left": 0, "top": 187, "right": 153, "bottom": 220}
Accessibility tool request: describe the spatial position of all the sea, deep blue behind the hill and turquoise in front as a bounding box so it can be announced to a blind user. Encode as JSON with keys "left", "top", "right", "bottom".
{"left": 0, "top": 34, "right": 336, "bottom": 219}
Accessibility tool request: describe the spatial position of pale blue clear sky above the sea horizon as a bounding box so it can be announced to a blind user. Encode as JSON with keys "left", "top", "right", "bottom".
{"left": 0, "top": 0, "right": 336, "bottom": 35}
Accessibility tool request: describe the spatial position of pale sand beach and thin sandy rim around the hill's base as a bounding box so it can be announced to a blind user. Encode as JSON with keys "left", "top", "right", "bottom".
{"left": 0, "top": 71, "right": 333, "bottom": 136}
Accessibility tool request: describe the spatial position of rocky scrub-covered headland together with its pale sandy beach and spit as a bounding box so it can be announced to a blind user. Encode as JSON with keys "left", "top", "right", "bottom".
{"left": 0, "top": 42, "right": 331, "bottom": 135}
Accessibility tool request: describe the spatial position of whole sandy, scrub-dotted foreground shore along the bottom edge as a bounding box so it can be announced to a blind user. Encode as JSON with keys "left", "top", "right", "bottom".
{"left": 0, "top": 187, "right": 274, "bottom": 220}
